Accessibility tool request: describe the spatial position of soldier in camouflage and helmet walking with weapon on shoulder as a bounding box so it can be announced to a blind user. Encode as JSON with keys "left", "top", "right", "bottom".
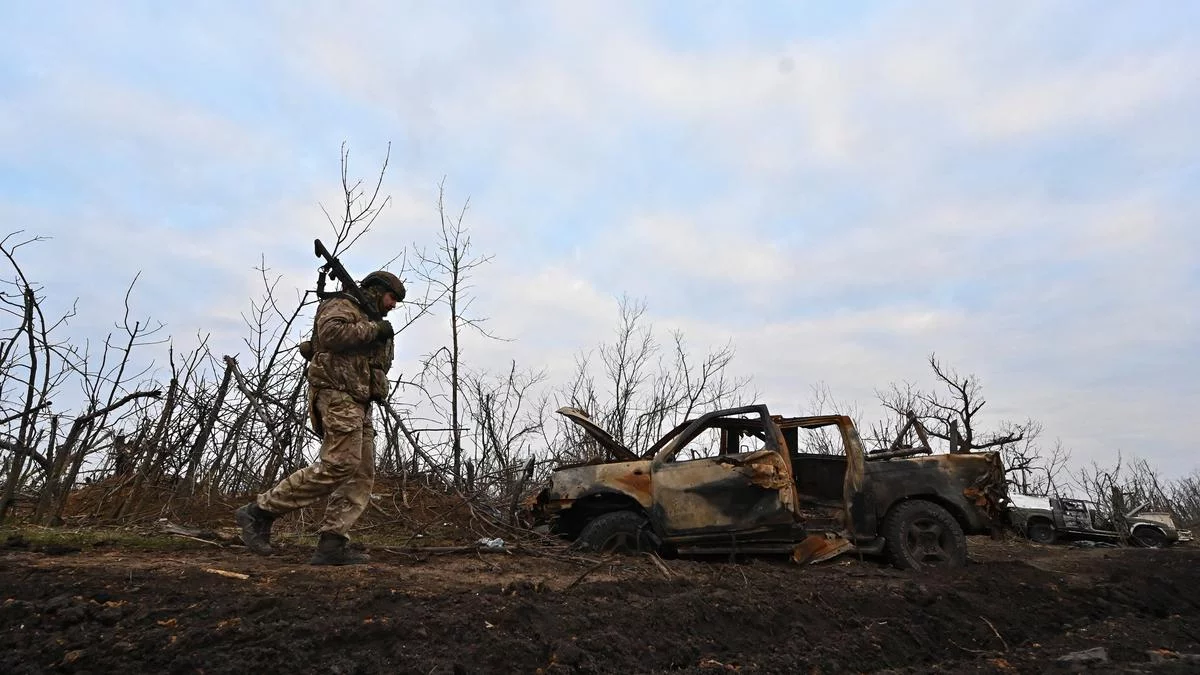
{"left": 234, "top": 270, "right": 404, "bottom": 565}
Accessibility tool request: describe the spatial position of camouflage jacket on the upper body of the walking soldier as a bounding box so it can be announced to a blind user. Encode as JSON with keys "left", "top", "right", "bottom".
{"left": 308, "top": 295, "right": 394, "bottom": 402}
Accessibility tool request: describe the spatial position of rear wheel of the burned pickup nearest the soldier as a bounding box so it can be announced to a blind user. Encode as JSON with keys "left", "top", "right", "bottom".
{"left": 883, "top": 500, "right": 967, "bottom": 569}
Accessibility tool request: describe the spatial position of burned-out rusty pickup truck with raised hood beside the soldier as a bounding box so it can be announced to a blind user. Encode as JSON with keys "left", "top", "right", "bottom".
{"left": 530, "top": 405, "right": 1004, "bottom": 569}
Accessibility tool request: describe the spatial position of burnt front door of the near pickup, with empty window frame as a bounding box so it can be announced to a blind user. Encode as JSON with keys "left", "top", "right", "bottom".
{"left": 650, "top": 406, "right": 797, "bottom": 538}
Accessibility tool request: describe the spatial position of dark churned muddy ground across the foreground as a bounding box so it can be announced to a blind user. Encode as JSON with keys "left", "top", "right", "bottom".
{"left": 0, "top": 534, "right": 1200, "bottom": 674}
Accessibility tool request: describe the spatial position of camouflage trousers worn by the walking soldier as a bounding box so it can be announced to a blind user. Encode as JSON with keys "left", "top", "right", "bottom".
{"left": 257, "top": 389, "right": 374, "bottom": 536}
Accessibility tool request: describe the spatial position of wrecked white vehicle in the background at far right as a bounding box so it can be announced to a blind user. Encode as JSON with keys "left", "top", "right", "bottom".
{"left": 1008, "top": 495, "right": 1192, "bottom": 549}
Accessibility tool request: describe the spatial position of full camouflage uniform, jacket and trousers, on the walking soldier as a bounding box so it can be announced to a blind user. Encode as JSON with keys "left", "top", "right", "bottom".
{"left": 256, "top": 288, "right": 394, "bottom": 537}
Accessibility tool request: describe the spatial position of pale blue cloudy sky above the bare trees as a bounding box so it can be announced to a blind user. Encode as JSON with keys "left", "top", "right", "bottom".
{"left": 0, "top": 0, "right": 1200, "bottom": 477}
